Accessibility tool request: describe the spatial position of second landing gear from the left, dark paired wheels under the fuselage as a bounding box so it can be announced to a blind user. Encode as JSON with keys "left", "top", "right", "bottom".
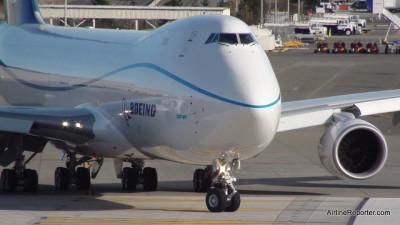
{"left": 54, "top": 152, "right": 97, "bottom": 190}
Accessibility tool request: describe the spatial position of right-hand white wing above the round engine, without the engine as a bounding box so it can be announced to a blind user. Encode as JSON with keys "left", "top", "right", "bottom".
{"left": 278, "top": 90, "right": 400, "bottom": 132}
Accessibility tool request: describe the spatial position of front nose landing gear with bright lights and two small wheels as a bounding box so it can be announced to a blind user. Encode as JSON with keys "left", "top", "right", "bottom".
{"left": 206, "top": 151, "right": 240, "bottom": 212}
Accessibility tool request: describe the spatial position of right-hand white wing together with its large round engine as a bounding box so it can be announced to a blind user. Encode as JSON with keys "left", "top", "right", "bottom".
{"left": 278, "top": 90, "right": 400, "bottom": 180}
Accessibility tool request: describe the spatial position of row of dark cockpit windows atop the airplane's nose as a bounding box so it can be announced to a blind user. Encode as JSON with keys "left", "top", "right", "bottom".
{"left": 205, "top": 33, "right": 255, "bottom": 45}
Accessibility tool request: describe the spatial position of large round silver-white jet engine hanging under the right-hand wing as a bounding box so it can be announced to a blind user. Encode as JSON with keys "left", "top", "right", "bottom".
{"left": 318, "top": 119, "right": 388, "bottom": 180}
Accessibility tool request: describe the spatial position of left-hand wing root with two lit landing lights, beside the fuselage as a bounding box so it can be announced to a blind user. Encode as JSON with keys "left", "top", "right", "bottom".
{"left": 0, "top": 106, "right": 95, "bottom": 144}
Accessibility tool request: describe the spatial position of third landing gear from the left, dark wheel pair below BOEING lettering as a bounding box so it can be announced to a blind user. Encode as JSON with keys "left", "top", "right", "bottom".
{"left": 121, "top": 160, "right": 158, "bottom": 191}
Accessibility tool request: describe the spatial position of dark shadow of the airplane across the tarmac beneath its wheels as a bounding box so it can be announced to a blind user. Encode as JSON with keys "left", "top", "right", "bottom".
{"left": 0, "top": 176, "right": 399, "bottom": 211}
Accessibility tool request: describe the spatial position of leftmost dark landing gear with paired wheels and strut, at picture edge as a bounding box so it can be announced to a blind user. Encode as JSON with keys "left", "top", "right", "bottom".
{"left": 0, "top": 135, "right": 39, "bottom": 192}
